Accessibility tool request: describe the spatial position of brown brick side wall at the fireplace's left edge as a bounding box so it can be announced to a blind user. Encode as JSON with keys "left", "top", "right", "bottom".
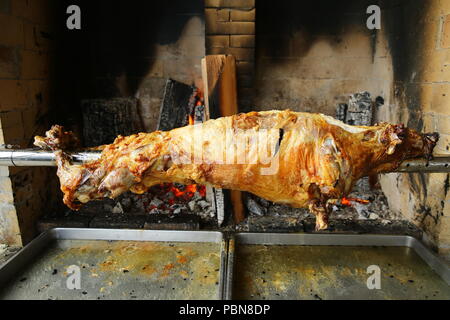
{"left": 0, "top": 0, "right": 56, "bottom": 245}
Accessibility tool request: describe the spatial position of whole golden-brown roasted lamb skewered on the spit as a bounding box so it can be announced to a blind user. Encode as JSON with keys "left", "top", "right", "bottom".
{"left": 36, "top": 110, "right": 438, "bottom": 230}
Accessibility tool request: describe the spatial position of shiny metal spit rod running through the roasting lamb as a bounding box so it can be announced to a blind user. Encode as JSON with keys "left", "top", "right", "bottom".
{"left": 0, "top": 149, "right": 450, "bottom": 173}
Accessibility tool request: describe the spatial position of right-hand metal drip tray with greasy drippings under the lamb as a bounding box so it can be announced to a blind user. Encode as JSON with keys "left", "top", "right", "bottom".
{"left": 226, "top": 233, "right": 450, "bottom": 300}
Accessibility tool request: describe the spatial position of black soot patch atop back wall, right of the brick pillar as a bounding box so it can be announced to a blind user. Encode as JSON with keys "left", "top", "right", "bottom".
{"left": 257, "top": 0, "right": 376, "bottom": 58}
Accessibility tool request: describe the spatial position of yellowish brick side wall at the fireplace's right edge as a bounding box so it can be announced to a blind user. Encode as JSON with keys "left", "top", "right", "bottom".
{"left": 379, "top": 0, "right": 450, "bottom": 260}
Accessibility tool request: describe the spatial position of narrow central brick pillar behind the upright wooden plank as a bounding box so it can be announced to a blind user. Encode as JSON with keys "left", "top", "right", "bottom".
{"left": 205, "top": 0, "right": 256, "bottom": 111}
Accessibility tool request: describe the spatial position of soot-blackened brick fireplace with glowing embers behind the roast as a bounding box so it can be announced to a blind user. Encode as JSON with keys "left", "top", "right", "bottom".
{"left": 0, "top": 0, "right": 450, "bottom": 264}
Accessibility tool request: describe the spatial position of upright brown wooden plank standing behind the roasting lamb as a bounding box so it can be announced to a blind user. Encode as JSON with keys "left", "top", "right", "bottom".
{"left": 202, "top": 55, "right": 245, "bottom": 223}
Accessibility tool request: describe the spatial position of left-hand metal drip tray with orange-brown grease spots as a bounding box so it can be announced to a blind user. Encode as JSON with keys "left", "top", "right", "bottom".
{"left": 0, "top": 229, "right": 226, "bottom": 300}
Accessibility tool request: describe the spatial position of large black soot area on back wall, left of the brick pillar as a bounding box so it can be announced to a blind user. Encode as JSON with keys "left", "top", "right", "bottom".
{"left": 55, "top": 0, "right": 204, "bottom": 130}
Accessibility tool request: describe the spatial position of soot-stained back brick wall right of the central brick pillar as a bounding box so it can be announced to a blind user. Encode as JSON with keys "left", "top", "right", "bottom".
{"left": 255, "top": 0, "right": 390, "bottom": 116}
